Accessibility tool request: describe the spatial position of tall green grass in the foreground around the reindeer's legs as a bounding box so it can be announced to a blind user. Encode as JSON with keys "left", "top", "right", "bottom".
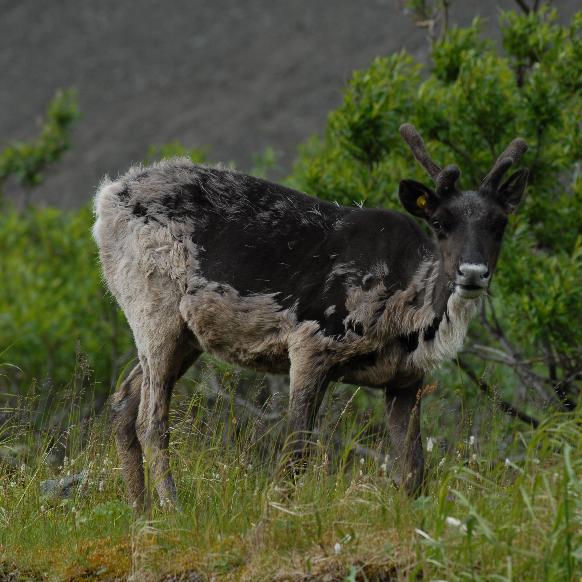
{"left": 0, "top": 374, "right": 582, "bottom": 580}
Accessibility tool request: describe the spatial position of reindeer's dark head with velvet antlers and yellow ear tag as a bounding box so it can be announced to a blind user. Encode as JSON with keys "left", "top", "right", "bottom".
{"left": 399, "top": 123, "right": 528, "bottom": 298}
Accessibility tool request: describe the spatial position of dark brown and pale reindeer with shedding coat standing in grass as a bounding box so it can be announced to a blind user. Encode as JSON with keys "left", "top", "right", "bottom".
{"left": 93, "top": 124, "right": 528, "bottom": 508}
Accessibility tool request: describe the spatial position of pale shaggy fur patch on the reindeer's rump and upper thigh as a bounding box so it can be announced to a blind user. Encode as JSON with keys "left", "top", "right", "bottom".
{"left": 93, "top": 169, "right": 198, "bottom": 364}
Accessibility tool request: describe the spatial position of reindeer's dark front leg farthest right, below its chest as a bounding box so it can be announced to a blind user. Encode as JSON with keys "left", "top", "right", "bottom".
{"left": 385, "top": 376, "right": 424, "bottom": 495}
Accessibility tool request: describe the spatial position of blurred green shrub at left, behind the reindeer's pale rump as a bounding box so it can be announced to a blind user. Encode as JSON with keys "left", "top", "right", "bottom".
{"left": 0, "top": 206, "right": 131, "bottom": 390}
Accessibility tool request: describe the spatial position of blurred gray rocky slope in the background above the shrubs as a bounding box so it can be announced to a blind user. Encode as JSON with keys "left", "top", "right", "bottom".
{"left": 0, "top": 0, "right": 578, "bottom": 207}
